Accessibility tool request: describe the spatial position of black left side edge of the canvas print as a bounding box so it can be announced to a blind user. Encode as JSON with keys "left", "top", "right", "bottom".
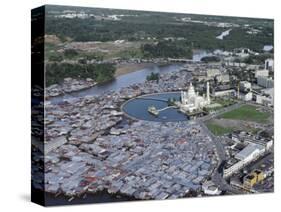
{"left": 31, "top": 6, "right": 46, "bottom": 206}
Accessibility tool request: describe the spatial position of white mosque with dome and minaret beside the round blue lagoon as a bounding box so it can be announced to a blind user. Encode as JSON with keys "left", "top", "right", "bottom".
{"left": 179, "top": 82, "right": 211, "bottom": 113}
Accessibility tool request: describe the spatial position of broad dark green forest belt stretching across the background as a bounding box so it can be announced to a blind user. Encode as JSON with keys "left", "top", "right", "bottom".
{"left": 46, "top": 14, "right": 273, "bottom": 52}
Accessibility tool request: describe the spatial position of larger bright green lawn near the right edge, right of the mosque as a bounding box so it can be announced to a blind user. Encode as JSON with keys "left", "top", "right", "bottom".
{"left": 217, "top": 105, "right": 270, "bottom": 123}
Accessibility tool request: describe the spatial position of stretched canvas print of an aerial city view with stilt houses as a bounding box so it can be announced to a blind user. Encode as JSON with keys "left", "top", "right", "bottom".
{"left": 32, "top": 5, "right": 274, "bottom": 205}
